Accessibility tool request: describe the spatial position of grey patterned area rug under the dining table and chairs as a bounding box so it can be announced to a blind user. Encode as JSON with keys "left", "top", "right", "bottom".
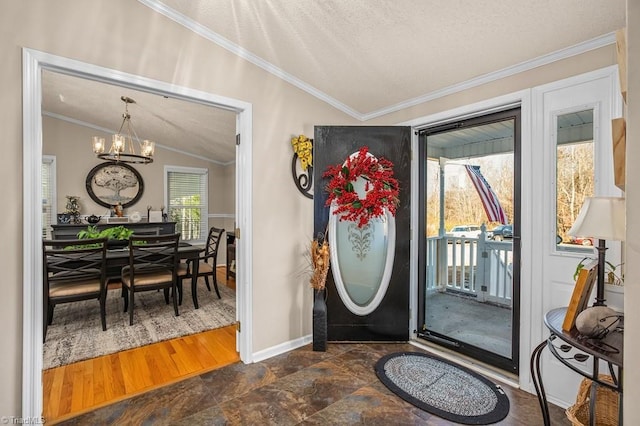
{"left": 43, "top": 279, "right": 236, "bottom": 370}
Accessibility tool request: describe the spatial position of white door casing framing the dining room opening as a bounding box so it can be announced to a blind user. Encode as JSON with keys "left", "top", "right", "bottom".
{"left": 22, "top": 49, "right": 252, "bottom": 416}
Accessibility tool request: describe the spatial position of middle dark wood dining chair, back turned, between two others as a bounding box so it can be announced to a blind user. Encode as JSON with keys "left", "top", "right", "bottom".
{"left": 121, "top": 234, "right": 180, "bottom": 325}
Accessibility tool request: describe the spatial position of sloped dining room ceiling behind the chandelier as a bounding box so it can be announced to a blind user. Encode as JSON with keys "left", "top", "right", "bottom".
{"left": 42, "top": 71, "right": 236, "bottom": 164}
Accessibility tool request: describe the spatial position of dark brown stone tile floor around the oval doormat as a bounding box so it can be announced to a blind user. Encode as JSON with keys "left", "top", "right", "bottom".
{"left": 63, "top": 343, "right": 570, "bottom": 426}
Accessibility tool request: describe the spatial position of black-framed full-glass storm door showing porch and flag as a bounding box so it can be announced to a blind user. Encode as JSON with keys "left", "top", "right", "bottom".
{"left": 418, "top": 107, "right": 521, "bottom": 374}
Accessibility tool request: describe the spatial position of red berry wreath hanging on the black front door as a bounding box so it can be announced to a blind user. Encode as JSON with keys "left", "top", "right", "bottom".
{"left": 322, "top": 146, "right": 400, "bottom": 228}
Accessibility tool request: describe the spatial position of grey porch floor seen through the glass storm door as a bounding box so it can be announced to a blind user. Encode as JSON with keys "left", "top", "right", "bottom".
{"left": 425, "top": 292, "right": 512, "bottom": 358}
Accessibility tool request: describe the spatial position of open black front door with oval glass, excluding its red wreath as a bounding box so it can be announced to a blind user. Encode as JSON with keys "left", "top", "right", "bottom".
{"left": 313, "top": 126, "right": 411, "bottom": 341}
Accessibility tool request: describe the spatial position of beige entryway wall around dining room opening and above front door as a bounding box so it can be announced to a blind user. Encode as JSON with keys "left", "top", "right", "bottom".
{"left": 0, "top": 0, "right": 632, "bottom": 415}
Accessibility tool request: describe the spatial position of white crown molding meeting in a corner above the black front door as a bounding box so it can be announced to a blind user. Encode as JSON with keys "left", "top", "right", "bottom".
{"left": 138, "top": 0, "right": 616, "bottom": 121}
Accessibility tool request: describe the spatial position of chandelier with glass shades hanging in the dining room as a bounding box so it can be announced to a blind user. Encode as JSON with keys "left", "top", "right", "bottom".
{"left": 93, "top": 96, "right": 155, "bottom": 164}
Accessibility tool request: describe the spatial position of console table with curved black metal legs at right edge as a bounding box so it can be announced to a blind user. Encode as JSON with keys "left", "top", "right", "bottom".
{"left": 530, "top": 308, "right": 623, "bottom": 426}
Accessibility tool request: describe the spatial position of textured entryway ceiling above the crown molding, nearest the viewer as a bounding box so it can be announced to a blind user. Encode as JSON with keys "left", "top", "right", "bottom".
{"left": 151, "top": 0, "right": 625, "bottom": 115}
